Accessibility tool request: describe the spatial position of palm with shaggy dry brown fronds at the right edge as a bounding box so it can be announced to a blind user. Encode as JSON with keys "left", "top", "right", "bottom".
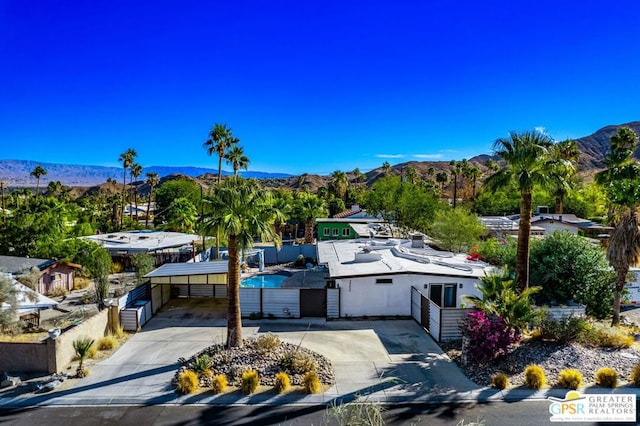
{"left": 596, "top": 127, "right": 640, "bottom": 325}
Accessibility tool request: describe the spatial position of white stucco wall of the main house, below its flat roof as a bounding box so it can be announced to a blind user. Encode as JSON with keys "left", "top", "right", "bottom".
{"left": 336, "top": 274, "right": 480, "bottom": 317}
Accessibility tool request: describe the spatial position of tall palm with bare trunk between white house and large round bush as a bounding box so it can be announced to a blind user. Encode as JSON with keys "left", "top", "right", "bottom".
{"left": 484, "top": 131, "right": 568, "bottom": 291}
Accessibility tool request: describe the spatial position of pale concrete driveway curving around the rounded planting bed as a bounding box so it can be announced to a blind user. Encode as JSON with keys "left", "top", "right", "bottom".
{"left": 4, "top": 315, "right": 478, "bottom": 405}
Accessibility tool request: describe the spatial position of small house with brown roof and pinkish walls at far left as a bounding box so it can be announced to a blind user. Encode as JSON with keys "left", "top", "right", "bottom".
{"left": 0, "top": 256, "right": 81, "bottom": 294}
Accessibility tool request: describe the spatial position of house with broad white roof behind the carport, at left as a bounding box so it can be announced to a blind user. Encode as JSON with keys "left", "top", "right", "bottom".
{"left": 82, "top": 230, "right": 202, "bottom": 269}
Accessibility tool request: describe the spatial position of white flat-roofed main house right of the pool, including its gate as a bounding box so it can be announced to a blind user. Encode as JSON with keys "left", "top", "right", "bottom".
{"left": 318, "top": 234, "right": 493, "bottom": 340}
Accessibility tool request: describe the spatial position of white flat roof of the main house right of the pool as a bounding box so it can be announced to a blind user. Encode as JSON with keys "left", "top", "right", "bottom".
{"left": 318, "top": 239, "right": 495, "bottom": 278}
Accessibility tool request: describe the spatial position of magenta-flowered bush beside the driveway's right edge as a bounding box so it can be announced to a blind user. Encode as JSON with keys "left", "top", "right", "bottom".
{"left": 460, "top": 311, "right": 520, "bottom": 364}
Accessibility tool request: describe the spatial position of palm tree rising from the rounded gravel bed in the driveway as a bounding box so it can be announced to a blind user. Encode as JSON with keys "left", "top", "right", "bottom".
{"left": 203, "top": 177, "right": 280, "bottom": 347}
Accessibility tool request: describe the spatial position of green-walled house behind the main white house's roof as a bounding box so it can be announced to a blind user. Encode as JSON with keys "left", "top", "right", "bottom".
{"left": 316, "top": 217, "right": 391, "bottom": 241}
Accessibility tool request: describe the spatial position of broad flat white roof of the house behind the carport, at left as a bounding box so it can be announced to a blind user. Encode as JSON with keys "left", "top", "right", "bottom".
{"left": 82, "top": 230, "right": 202, "bottom": 252}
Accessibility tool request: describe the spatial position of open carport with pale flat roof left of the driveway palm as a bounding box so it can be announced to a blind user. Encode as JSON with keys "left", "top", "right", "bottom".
{"left": 144, "top": 261, "right": 229, "bottom": 314}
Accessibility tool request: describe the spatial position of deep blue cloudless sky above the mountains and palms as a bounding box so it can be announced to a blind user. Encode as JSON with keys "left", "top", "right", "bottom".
{"left": 0, "top": 0, "right": 640, "bottom": 174}
